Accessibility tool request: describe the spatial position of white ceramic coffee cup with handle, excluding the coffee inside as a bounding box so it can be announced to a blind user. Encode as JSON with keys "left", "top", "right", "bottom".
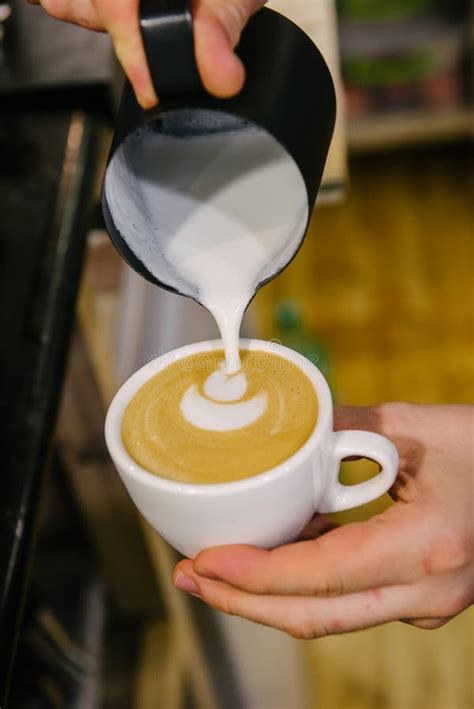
{"left": 105, "top": 340, "right": 398, "bottom": 558}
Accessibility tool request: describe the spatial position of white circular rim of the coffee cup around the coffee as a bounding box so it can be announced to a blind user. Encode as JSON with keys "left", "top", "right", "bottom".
{"left": 105, "top": 338, "right": 333, "bottom": 496}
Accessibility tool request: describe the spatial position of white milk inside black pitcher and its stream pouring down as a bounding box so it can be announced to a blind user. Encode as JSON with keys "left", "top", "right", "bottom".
{"left": 105, "top": 112, "right": 308, "bottom": 418}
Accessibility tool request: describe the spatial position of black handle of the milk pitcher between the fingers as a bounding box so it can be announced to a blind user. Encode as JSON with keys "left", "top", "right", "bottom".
{"left": 140, "top": 0, "right": 202, "bottom": 96}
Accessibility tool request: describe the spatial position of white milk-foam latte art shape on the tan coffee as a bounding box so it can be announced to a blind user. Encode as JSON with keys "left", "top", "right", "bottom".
{"left": 180, "top": 371, "right": 267, "bottom": 431}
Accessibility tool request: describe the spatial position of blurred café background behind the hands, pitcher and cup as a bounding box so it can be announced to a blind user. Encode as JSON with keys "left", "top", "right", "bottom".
{"left": 0, "top": 0, "right": 474, "bottom": 709}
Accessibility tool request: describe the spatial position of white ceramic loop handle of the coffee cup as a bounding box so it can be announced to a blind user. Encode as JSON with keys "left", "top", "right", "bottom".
{"left": 318, "top": 431, "right": 399, "bottom": 512}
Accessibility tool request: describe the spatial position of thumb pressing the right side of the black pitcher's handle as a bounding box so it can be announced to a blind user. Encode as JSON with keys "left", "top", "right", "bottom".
{"left": 193, "top": 0, "right": 265, "bottom": 98}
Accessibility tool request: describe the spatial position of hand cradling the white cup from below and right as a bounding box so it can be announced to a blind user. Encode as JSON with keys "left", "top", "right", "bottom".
{"left": 174, "top": 404, "right": 474, "bottom": 638}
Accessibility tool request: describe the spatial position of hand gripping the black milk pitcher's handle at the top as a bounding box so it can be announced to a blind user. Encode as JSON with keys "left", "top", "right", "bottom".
{"left": 28, "top": 0, "right": 266, "bottom": 108}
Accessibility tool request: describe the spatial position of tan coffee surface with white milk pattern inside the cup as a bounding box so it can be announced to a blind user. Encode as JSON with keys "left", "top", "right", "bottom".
{"left": 122, "top": 351, "right": 318, "bottom": 483}
